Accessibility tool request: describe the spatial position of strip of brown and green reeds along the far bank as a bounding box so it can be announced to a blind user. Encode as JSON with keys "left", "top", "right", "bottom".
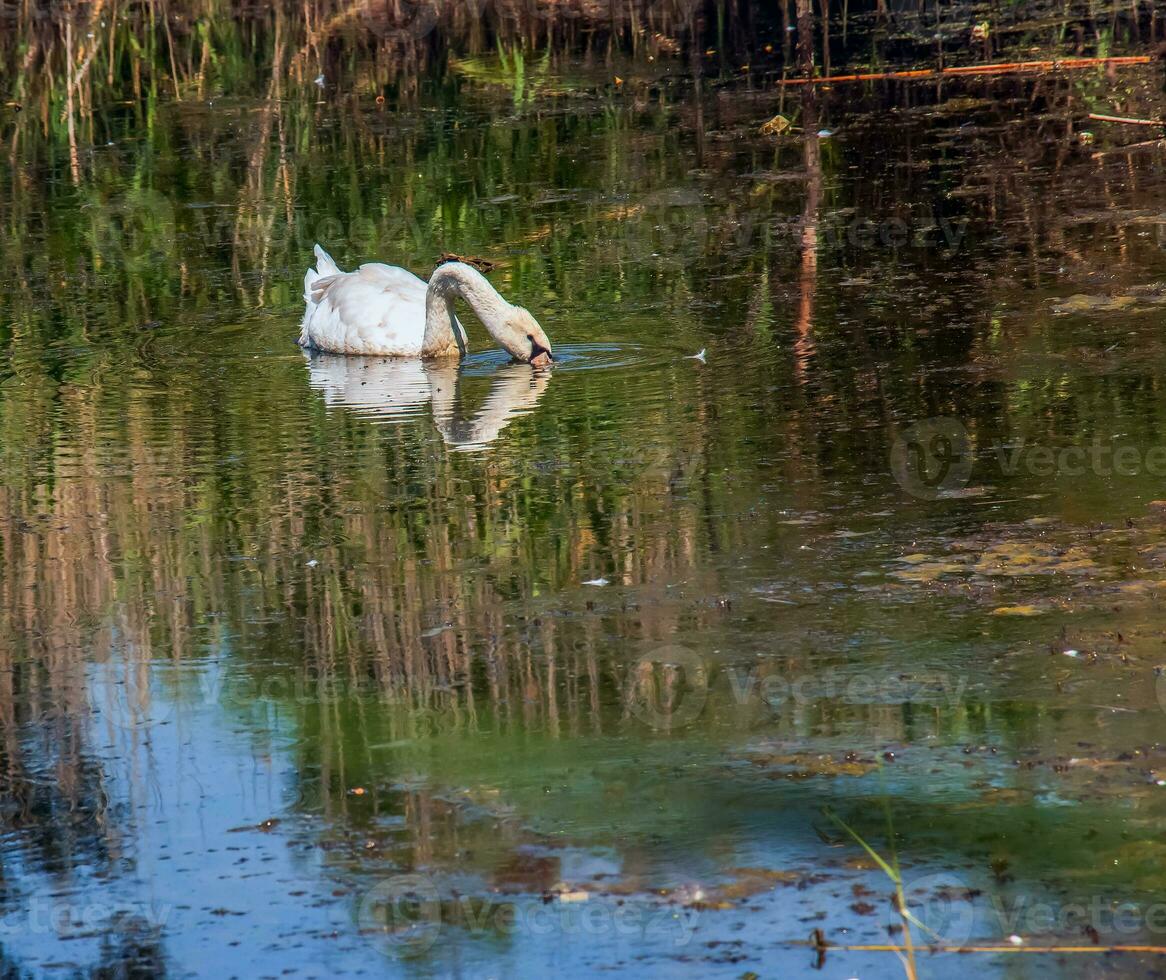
{"left": 0, "top": 0, "right": 1163, "bottom": 122}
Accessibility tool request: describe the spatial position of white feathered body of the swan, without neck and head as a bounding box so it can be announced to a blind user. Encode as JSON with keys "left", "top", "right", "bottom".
{"left": 300, "top": 245, "right": 465, "bottom": 357}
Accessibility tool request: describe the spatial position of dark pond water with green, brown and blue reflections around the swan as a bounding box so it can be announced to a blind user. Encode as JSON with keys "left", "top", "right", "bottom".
{"left": 0, "top": 38, "right": 1166, "bottom": 977}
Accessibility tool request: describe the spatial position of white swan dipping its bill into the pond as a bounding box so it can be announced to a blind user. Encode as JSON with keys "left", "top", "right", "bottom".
{"left": 300, "top": 245, "right": 554, "bottom": 366}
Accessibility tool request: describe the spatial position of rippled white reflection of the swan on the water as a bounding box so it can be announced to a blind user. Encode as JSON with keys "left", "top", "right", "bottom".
{"left": 308, "top": 354, "right": 552, "bottom": 452}
